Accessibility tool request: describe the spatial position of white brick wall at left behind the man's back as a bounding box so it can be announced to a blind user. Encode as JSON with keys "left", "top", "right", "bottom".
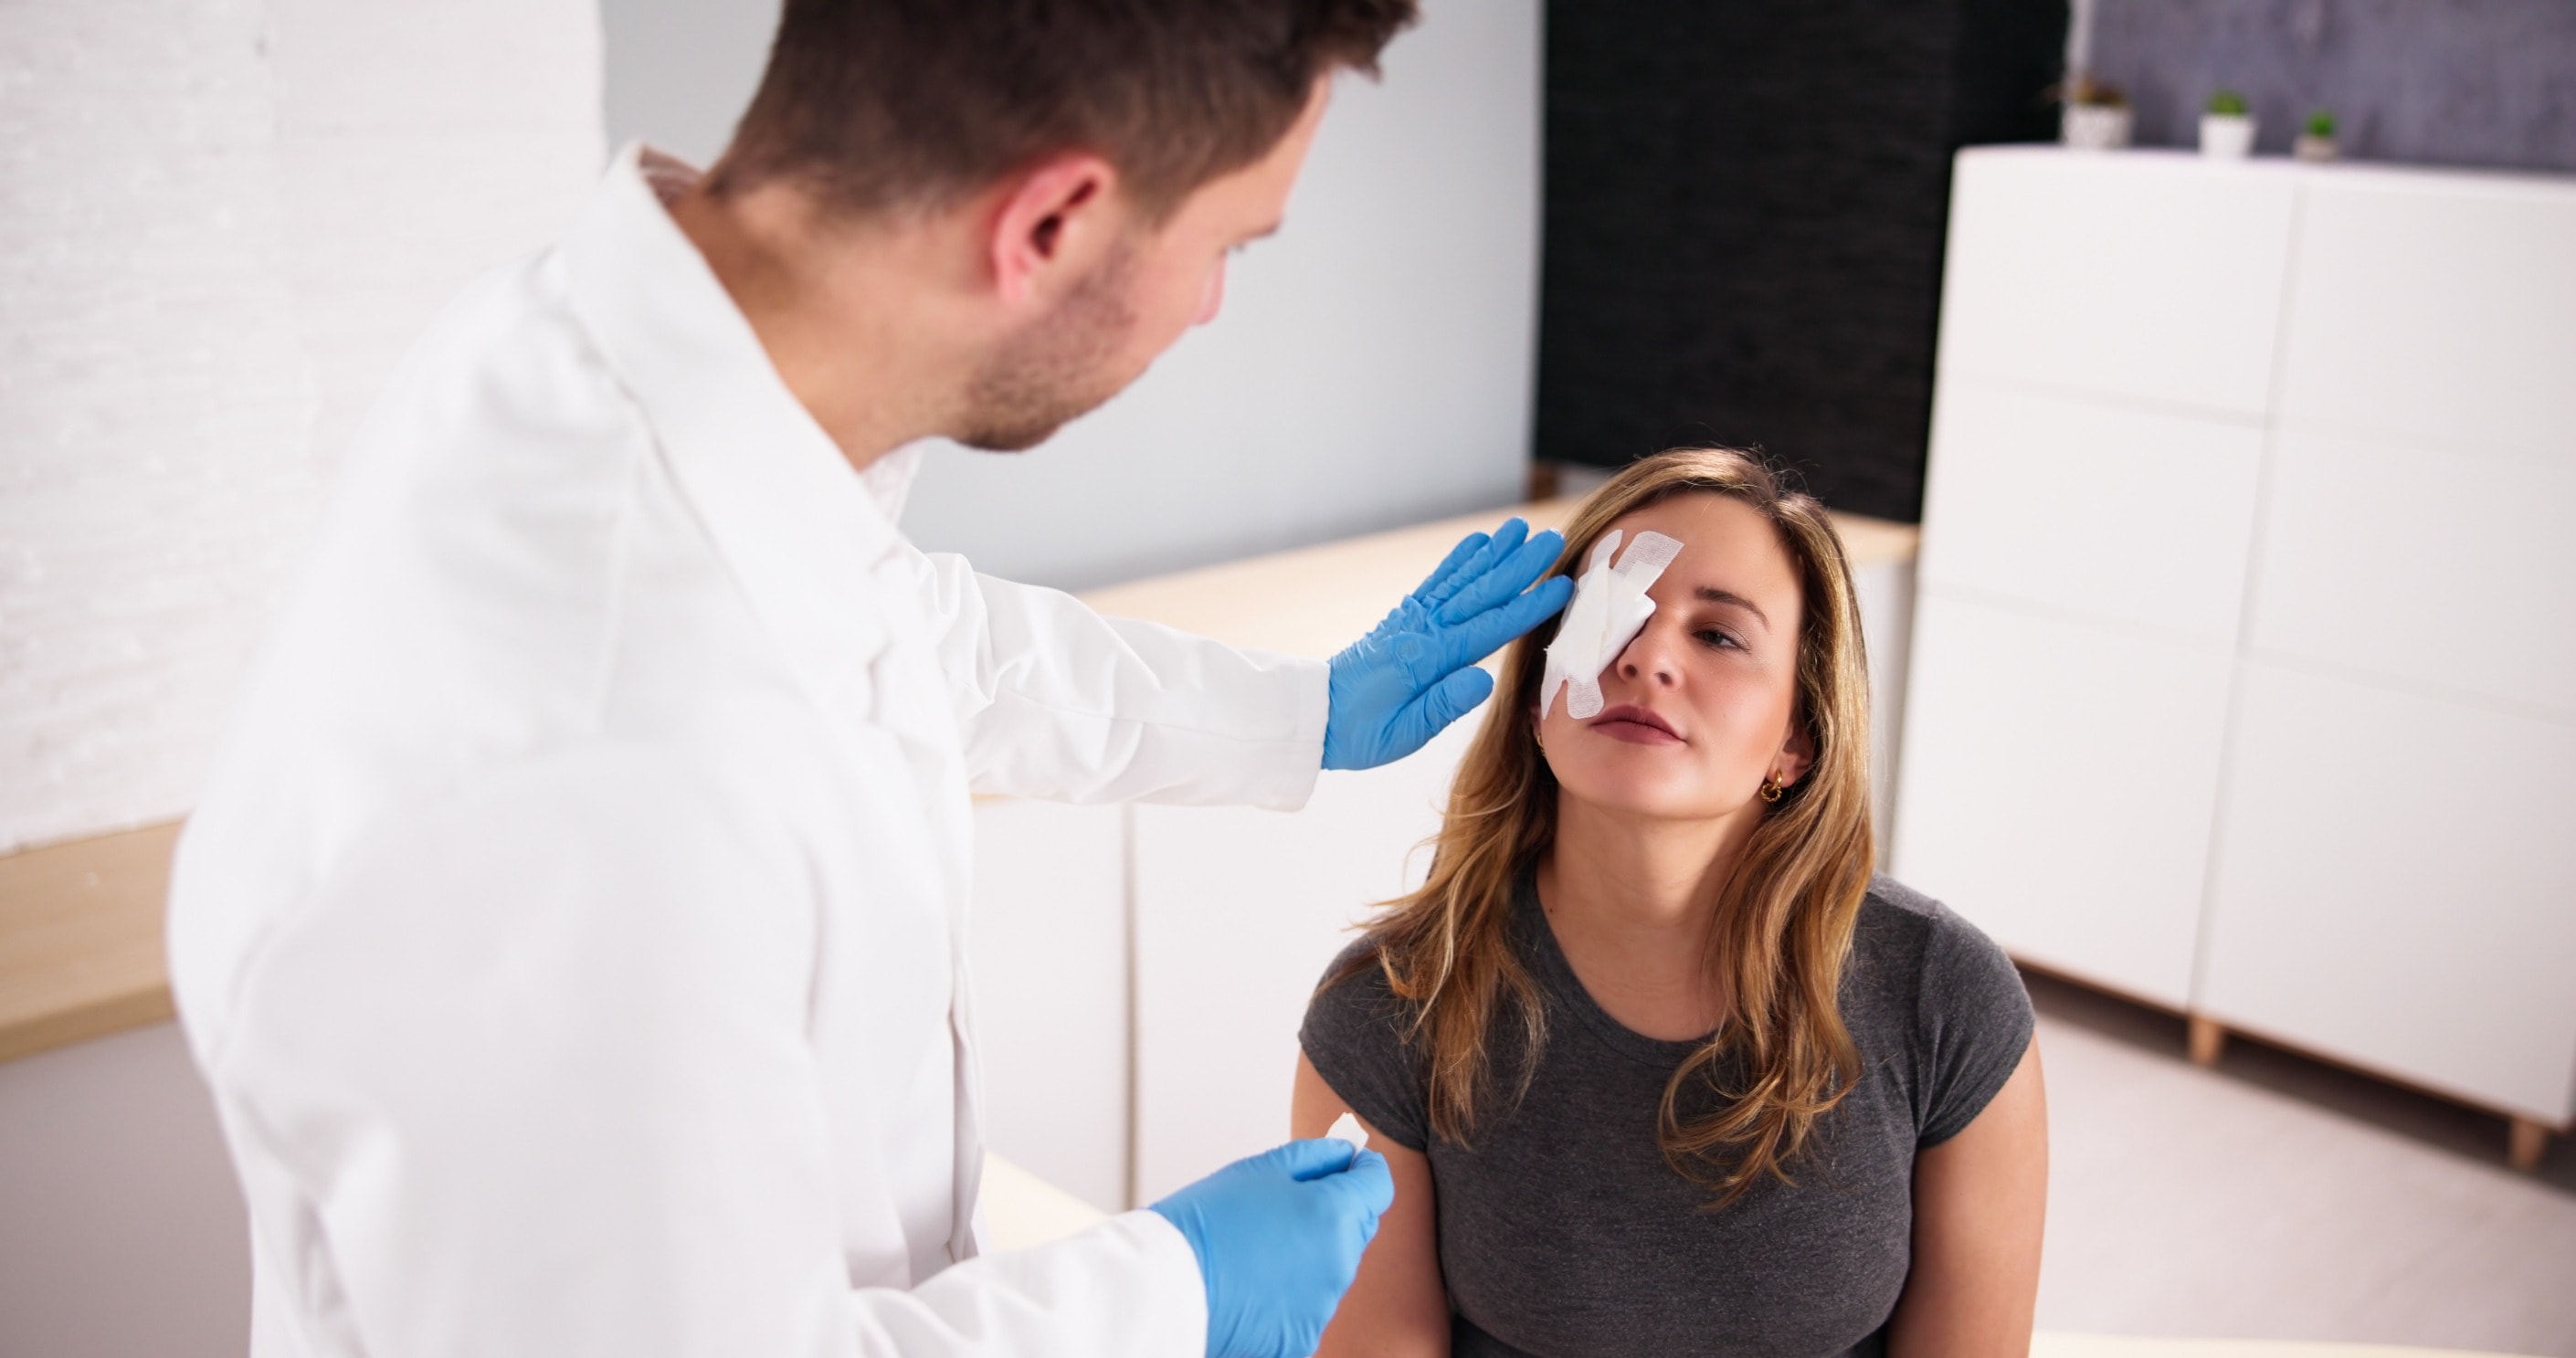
{"left": 0, "top": 0, "right": 606, "bottom": 853}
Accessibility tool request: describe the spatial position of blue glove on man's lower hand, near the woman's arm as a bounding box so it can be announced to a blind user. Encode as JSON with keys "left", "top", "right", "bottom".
{"left": 1154, "top": 1136, "right": 1396, "bottom": 1358}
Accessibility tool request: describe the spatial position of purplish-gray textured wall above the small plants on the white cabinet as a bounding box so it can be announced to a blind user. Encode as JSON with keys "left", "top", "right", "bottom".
{"left": 2089, "top": 0, "right": 2576, "bottom": 170}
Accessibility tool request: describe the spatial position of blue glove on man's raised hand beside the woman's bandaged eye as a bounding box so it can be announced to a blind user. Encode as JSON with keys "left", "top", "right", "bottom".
{"left": 1324, "top": 518, "right": 1574, "bottom": 768}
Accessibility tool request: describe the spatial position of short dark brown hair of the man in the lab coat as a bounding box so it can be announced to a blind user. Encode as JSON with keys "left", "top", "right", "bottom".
{"left": 709, "top": 0, "right": 1414, "bottom": 219}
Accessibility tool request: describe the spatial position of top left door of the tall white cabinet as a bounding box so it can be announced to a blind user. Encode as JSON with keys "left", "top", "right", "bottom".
{"left": 1939, "top": 147, "right": 2297, "bottom": 415}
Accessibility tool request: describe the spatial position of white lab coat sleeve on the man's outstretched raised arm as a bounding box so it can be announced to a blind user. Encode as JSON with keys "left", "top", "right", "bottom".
{"left": 904, "top": 546, "right": 1326, "bottom": 809}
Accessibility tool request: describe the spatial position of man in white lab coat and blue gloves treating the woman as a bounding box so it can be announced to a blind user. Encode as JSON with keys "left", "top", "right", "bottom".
{"left": 170, "top": 0, "right": 1567, "bottom": 1358}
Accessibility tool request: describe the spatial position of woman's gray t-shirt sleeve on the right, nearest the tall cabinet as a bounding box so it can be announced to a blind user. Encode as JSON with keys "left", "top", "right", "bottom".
{"left": 1914, "top": 904, "right": 2032, "bottom": 1147}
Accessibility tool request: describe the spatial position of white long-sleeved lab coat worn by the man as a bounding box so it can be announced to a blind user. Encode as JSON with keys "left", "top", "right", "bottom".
{"left": 165, "top": 150, "right": 1324, "bottom": 1358}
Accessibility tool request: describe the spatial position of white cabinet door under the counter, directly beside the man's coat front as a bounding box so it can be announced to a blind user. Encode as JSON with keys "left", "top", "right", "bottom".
{"left": 966, "top": 802, "right": 1128, "bottom": 1211}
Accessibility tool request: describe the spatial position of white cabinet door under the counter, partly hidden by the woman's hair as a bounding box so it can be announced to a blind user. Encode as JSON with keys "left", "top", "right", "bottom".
{"left": 1134, "top": 716, "right": 1482, "bottom": 1201}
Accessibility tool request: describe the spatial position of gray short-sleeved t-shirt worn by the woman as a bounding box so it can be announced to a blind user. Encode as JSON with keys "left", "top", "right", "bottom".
{"left": 1298, "top": 876, "right": 2032, "bottom": 1358}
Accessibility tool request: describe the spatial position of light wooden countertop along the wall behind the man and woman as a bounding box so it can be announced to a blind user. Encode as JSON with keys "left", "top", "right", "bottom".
{"left": 0, "top": 498, "right": 1914, "bottom": 1062}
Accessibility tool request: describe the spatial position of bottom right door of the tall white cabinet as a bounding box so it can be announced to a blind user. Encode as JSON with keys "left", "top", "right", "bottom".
{"left": 2200, "top": 662, "right": 2576, "bottom": 1121}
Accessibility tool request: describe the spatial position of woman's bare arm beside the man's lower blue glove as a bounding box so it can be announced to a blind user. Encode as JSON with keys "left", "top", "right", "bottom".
{"left": 1288, "top": 1051, "right": 1448, "bottom": 1358}
